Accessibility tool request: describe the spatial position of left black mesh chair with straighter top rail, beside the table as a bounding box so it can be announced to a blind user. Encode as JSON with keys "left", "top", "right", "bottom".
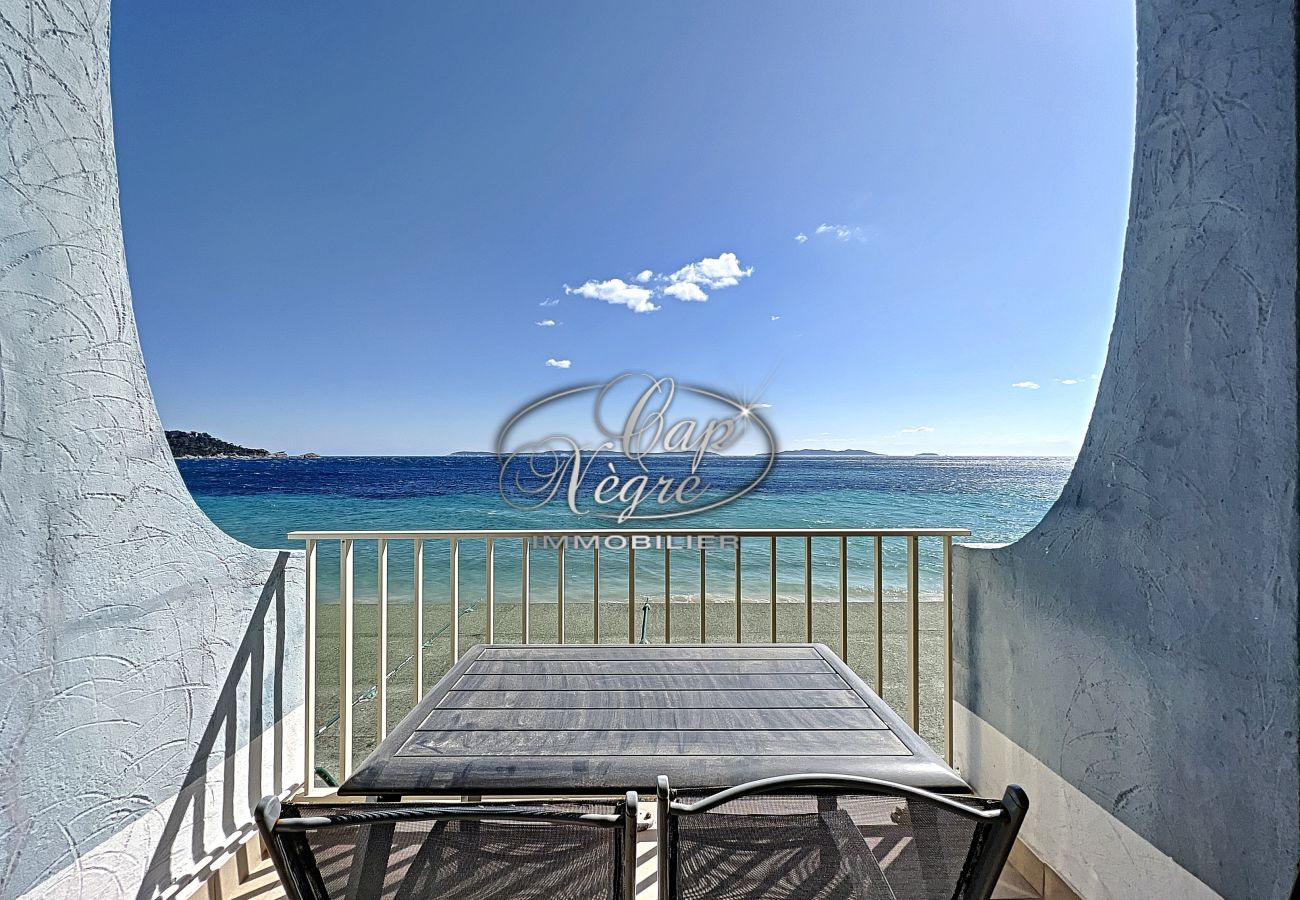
{"left": 256, "top": 793, "right": 637, "bottom": 900}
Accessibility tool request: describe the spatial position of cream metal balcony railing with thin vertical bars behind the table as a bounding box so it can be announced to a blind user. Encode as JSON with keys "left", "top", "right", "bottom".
{"left": 289, "top": 528, "right": 970, "bottom": 792}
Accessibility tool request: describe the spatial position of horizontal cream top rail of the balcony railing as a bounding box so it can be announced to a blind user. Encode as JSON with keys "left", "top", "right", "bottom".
{"left": 287, "top": 528, "right": 971, "bottom": 541}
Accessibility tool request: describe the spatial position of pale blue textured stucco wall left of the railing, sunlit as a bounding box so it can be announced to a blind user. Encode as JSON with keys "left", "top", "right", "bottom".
{"left": 0, "top": 0, "right": 302, "bottom": 899}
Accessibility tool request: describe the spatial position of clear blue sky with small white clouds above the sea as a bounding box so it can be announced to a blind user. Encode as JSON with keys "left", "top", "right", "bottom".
{"left": 113, "top": 0, "right": 1135, "bottom": 454}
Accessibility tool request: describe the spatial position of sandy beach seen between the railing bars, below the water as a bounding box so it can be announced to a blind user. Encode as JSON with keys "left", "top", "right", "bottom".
{"left": 316, "top": 600, "right": 944, "bottom": 774}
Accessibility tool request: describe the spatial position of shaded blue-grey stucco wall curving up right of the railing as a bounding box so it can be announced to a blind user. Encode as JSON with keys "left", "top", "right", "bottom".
{"left": 954, "top": 0, "right": 1300, "bottom": 900}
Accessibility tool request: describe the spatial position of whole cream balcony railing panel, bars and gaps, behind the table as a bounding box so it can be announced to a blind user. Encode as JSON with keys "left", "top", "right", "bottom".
{"left": 289, "top": 528, "right": 970, "bottom": 792}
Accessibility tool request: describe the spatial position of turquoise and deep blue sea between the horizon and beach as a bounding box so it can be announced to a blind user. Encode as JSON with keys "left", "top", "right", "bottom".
{"left": 178, "top": 457, "right": 1073, "bottom": 603}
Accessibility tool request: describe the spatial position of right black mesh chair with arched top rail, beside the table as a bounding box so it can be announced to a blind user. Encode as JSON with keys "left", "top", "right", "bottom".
{"left": 658, "top": 775, "right": 1028, "bottom": 900}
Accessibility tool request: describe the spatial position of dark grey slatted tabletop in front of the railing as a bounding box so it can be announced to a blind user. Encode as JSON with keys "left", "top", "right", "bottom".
{"left": 338, "top": 644, "right": 970, "bottom": 797}
